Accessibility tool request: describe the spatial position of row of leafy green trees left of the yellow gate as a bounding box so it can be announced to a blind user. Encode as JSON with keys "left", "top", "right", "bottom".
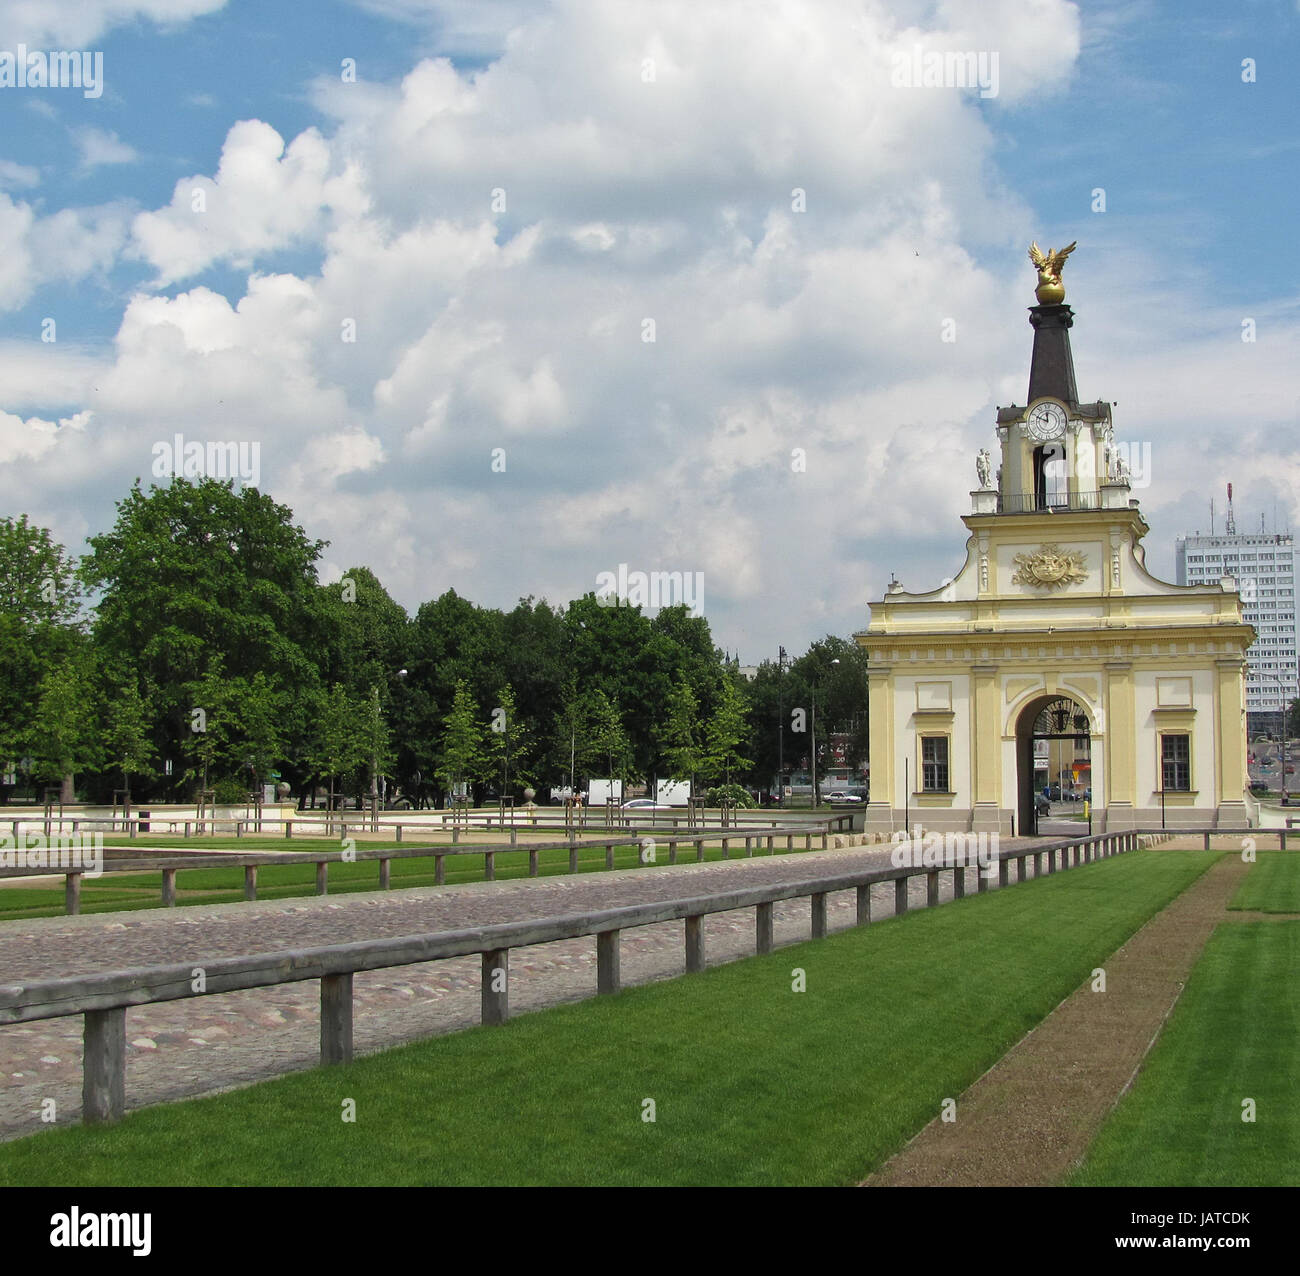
{"left": 0, "top": 478, "right": 866, "bottom": 802}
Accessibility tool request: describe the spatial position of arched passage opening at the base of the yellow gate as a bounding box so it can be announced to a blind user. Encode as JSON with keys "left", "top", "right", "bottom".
{"left": 1015, "top": 695, "right": 1092, "bottom": 836}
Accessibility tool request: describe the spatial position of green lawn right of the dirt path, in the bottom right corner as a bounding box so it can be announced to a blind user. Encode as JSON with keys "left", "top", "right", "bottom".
{"left": 1070, "top": 919, "right": 1300, "bottom": 1188}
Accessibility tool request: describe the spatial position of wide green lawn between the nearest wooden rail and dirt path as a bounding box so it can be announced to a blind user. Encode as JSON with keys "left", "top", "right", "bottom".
{"left": 0, "top": 851, "right": 1218, "bottom": 1185}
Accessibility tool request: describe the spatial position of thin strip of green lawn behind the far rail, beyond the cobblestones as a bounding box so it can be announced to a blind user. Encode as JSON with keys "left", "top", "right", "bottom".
{"left": 0, "top": 838, "right": 800, "bottom": 920}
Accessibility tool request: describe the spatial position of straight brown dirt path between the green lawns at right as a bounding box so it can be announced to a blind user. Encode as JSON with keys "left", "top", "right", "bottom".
{"left": 863, "top": 855, "right": 1251, "bottom": 1188}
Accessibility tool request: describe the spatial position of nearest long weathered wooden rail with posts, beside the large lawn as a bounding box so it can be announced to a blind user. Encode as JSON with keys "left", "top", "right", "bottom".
{"left": 0, "top": 832, "right": 1140, "bottom": 1123}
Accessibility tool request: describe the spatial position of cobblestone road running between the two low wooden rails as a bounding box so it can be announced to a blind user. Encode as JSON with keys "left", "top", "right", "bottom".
{"left": 0, "top": 841, "right": 1045, "bottom": 1140}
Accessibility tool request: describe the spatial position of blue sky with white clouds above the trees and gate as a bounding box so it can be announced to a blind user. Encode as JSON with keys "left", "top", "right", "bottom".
{"left": 0, "top": 0, "right": 1300, "bottom": 664}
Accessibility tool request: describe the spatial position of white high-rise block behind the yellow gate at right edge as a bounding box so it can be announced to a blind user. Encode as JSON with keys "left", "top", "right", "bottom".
{"left": 1174, "top": 531, "right": 1300, "bottom": 738}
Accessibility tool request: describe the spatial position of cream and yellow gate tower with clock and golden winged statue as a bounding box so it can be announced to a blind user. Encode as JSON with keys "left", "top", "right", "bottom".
{"left": 857, "top": 244, "right": 1257, "bottom": 834}
